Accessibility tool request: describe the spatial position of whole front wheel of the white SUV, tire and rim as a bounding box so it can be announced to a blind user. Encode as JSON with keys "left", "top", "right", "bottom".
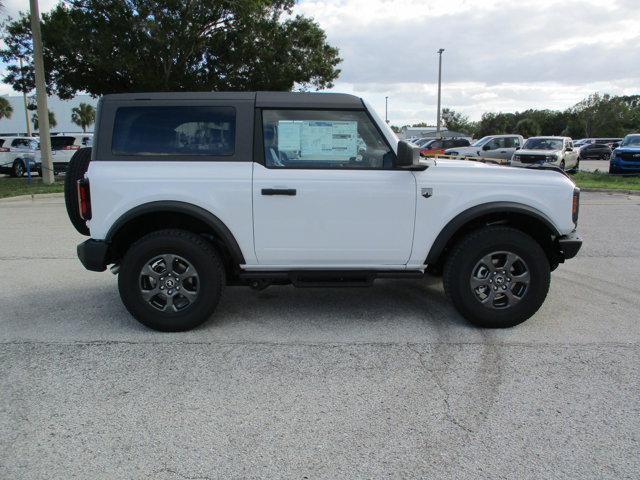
{"left": 443, "top": 227, "right": 550, "bottom": 328}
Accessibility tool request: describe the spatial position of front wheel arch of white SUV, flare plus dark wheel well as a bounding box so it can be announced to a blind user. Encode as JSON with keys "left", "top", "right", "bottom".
{"left": 425, "top": 202, "right": 561, "bottom": 266}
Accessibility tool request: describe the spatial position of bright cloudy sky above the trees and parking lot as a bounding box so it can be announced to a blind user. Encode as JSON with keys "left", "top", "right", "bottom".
{"left": 0, "top": 0, "right": 640, "bottom": 125}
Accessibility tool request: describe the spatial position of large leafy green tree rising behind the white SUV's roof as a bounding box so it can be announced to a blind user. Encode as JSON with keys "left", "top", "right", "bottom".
{"left": 0, "top": 0, "right": 341, "bottom": 98}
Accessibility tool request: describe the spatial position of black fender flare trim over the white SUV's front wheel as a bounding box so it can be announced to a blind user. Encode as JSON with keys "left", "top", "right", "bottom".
{"left": 425, "top": 202, "right": 560, "bottom": 264}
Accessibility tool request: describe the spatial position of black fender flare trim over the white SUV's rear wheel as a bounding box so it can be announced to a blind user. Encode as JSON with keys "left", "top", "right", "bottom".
{"left": 105, "top": 200, "right": 245, "bottom": 265}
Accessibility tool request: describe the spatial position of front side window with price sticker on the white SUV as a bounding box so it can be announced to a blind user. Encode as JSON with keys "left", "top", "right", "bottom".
{"left": 262, "top": 110, "right": 395, "bottom": 169}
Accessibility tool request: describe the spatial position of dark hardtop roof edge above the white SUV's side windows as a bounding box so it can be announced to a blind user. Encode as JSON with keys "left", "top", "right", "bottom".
{"left": 102, "top": 92, "right": 363, "bottom": 109}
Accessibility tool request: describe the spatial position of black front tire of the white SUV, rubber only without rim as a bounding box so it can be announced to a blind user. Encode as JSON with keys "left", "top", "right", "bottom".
{"left": 443, "top": 227, "right": 550, "bottom": 328}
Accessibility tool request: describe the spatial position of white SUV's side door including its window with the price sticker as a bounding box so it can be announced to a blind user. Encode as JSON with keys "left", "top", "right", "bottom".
{"left": 253, "top": 109, "right": 417, "bottom": 269}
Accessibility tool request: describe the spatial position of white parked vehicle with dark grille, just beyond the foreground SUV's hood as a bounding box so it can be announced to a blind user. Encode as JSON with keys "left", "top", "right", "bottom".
{"left": 510, "top": 137, "right": 580, "bottom": 172}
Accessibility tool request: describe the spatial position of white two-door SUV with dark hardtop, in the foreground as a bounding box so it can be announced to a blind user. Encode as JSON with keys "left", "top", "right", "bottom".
{"left": 65, "top": 92, "right": 581, "bottom": 331}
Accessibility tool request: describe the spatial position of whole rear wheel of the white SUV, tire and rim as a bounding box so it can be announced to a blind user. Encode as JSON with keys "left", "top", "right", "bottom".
{"left": 118, "top": 230, "right": 225, "bottom": 332}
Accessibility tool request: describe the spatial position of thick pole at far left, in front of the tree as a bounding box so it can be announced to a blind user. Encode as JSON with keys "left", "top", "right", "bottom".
{"left": 30, "top": 0, "right": 55, "bottom": 185}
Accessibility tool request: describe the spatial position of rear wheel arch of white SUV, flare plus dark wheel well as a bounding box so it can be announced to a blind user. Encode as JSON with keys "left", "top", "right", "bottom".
{"left": 105, "top": 200, "right": 245, "bottom": 266}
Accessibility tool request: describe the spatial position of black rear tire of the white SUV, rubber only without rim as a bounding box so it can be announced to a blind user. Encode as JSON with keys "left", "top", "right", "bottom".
{"left": 118, "top": 229, "right": 225, "bottom": 332}
